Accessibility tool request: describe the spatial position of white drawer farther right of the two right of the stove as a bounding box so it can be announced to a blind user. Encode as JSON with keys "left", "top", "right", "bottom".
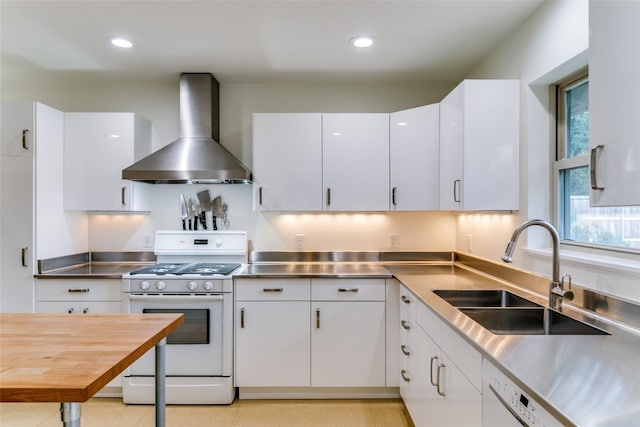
{"left": 311, "top": 279, "right": 386, "bottom": 301}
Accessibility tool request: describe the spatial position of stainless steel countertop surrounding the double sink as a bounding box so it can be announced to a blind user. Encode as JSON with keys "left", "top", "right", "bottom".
{"left": 396, "top": 266, "right": 640, "bottom": 426}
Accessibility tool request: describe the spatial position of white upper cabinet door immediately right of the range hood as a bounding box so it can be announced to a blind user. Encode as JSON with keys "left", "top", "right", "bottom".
{"left": 253, "top": 113, "right": 322, "bottom": 211}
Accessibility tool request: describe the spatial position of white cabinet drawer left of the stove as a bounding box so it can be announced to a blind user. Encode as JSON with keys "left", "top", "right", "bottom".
{"left": 36, "top": 280, "right": 122, "bottom": 301}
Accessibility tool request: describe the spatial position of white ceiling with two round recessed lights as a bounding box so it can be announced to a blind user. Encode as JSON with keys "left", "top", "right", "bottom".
{"left": 0, "top": 0, "right": 543, "bottom": 83}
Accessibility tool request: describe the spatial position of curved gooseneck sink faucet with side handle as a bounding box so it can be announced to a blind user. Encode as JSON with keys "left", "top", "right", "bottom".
{"left": 501, "top": 219, "right": 573, "bottom": 311}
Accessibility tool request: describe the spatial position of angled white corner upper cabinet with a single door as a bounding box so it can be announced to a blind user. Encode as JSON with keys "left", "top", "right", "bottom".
{"left": 389, "top": 104, "right": 440, "bottom": 211}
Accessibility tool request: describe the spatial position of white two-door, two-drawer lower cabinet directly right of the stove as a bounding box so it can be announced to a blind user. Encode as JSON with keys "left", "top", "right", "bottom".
{"left": 235, "top": 278, "right": 386, "bottom": 387}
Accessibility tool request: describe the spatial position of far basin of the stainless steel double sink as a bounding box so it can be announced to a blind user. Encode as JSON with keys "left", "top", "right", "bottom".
{"left": 433, "top": 289, "right": 542, "bottom": 307}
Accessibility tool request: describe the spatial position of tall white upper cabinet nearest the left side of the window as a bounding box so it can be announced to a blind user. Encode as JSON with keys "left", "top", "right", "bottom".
{"left": 440, "top": 80, "right": 520, "bottom": 210}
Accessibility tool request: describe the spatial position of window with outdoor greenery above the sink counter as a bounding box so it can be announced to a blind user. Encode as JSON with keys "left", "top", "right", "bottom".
{"left": 554, "top": 74, "right": 640, "bottom": 250}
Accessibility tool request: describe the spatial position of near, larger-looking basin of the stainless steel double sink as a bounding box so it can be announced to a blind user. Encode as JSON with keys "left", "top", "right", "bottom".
{"left": 460, "top": 307, "right": 610, "bottom": 335}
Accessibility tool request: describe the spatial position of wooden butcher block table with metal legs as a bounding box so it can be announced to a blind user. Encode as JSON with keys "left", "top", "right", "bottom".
{"left": 0, "top": 313, "right": 184, "bottom": 426}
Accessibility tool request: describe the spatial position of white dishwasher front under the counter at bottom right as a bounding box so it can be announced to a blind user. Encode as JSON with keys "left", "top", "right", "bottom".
{"left": 482, "top": 359, "right": 563, "bottom": 427}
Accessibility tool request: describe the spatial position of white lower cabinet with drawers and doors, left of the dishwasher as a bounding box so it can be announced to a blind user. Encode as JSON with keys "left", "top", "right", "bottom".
{"left": 400, "top": 286, "right": 482, "bottom": 427}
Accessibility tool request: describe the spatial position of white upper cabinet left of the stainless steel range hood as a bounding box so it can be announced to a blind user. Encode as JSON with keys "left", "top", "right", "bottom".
{"left": 64, "top": 113, "right": 151, "bottom": 212}
